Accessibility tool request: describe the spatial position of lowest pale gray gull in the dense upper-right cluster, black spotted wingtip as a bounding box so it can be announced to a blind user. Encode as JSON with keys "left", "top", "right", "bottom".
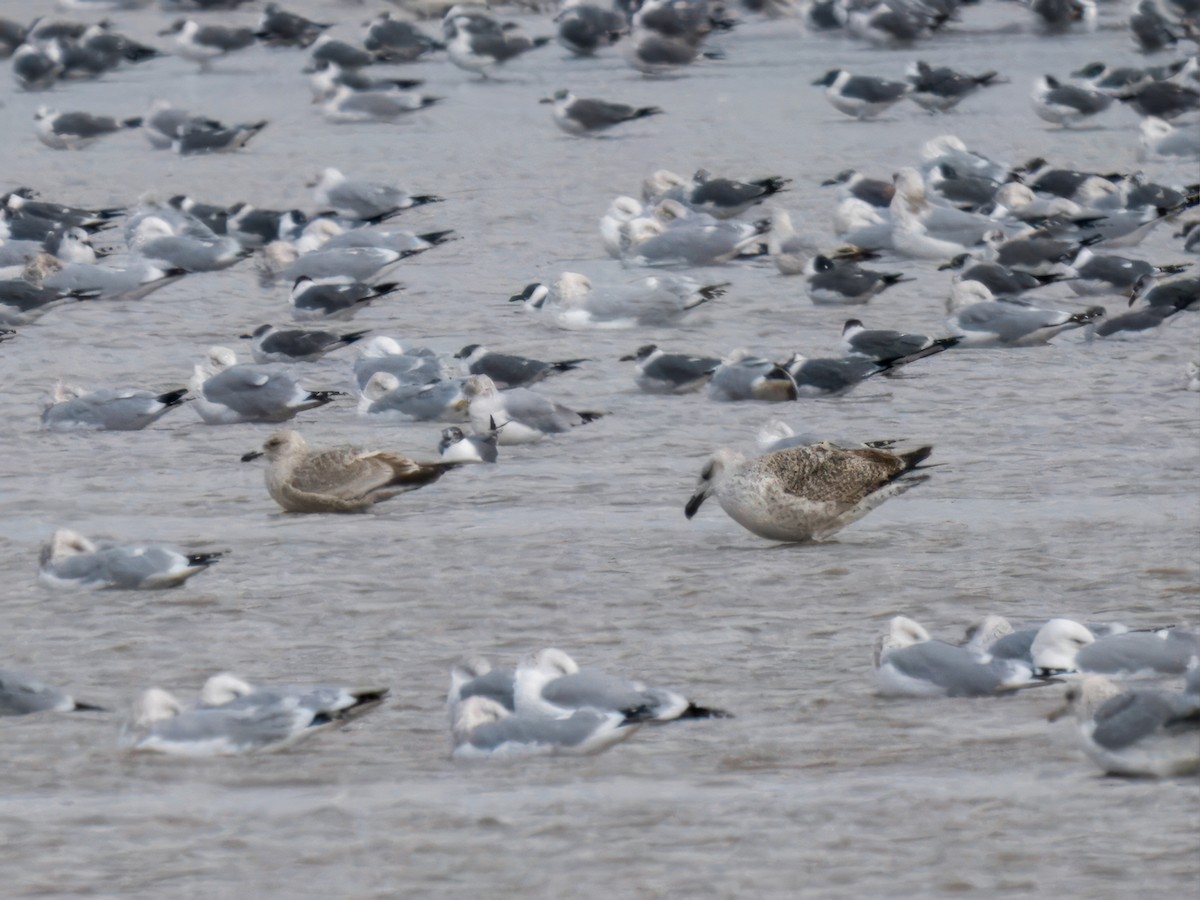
{"left": 946, "top": 281, "right": 1105, "bottom": 347}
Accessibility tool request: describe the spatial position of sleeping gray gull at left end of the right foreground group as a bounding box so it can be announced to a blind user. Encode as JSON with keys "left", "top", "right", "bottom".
{"left": 875, "top": 616, "right": 1042, "bottom": 697}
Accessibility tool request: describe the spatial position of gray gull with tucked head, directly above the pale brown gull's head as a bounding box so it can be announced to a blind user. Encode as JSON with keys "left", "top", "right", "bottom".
{"left": 188, "top": 347, "right": 344, "bottom": 425}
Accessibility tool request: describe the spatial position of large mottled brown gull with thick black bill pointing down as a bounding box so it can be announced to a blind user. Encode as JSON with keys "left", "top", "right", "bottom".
{"left": 684, "top": 444, "right": 932, "bottom": 541}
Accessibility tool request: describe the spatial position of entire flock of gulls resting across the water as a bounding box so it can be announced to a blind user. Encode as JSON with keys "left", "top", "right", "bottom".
{"left": 0, "top": 0, "right": 1200, "bottom": 775}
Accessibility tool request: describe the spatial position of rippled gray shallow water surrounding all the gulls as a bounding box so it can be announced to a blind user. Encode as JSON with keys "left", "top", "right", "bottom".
{"left": 0, "top": 0, "right": 1200, "bottom": 898}
